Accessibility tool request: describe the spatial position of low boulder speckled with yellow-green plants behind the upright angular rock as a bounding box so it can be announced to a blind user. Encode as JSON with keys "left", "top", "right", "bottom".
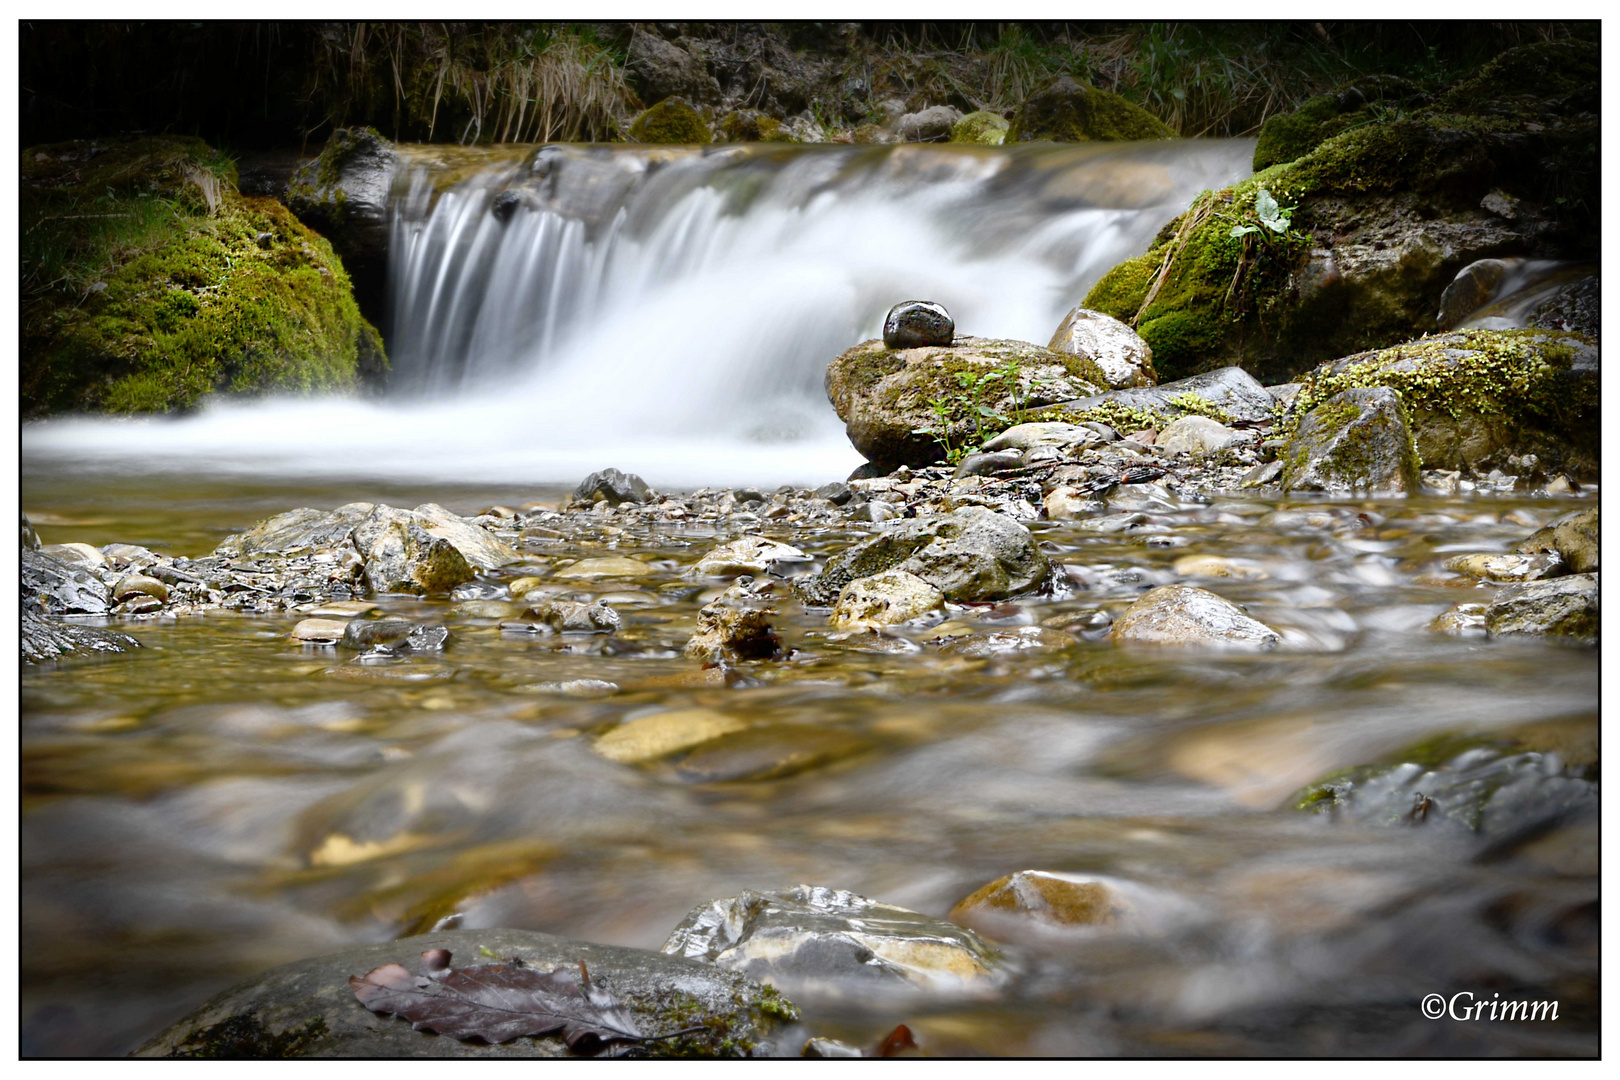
{"left": 1291, "top": 330, "right": 1599, "bottom": 479}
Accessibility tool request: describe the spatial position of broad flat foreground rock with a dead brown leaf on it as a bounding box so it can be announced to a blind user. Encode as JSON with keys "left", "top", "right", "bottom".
{"left": 134, "top": 929, "right": 802, "bottom": 1059}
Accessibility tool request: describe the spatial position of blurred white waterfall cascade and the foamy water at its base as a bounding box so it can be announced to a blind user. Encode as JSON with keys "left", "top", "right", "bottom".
{"left": 23, "top": 139, "right": 1252, "bottom": 487}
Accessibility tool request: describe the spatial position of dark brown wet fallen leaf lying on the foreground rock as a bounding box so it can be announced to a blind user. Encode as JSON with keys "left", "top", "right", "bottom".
{"left": 348, "top": 949, "right": 657, "bottom": 1052}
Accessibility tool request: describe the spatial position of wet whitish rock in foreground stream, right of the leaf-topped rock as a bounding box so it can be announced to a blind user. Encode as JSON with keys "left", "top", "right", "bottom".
{"left": 664, "top": 886, "right": 996, "bottom": 997}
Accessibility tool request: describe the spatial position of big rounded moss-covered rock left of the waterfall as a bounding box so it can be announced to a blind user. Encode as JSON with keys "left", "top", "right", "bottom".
{"left": 21, "top": 136, "right": 387, "bottom": 416}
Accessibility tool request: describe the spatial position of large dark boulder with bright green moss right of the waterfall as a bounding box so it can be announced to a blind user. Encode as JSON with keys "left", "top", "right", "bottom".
{"left": 1084, "top": 44, "right": 1597, "bottom": 382}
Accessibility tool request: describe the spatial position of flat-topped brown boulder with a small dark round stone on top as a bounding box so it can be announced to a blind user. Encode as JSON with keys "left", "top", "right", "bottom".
{"left": 826, "top": 337, "right": 1105, "bottom": 463}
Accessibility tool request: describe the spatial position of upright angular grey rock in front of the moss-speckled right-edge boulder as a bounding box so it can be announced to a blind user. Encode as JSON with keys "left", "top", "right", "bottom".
{"left": 1281, "top": 387, "right": 1419, "bottom": 492}
